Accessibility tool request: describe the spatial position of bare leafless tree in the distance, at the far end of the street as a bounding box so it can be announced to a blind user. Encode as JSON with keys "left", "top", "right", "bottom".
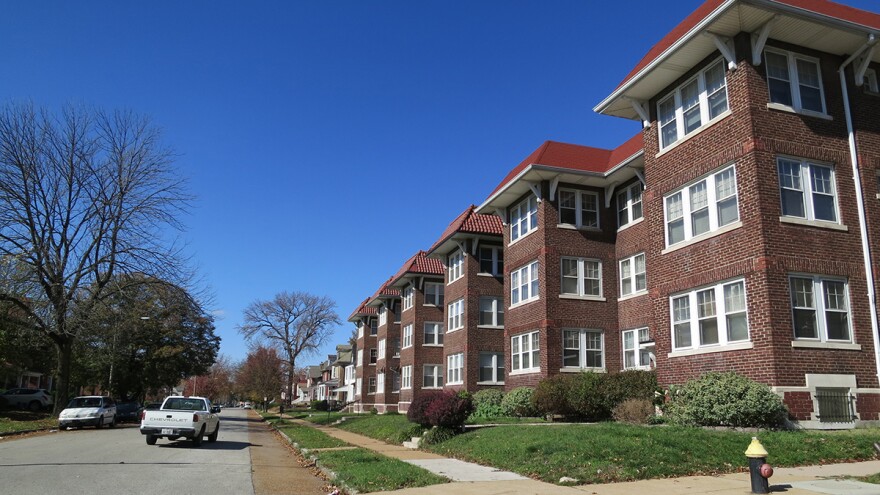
{"left": 238, "top": 292, "right": 341, "bottom": 405}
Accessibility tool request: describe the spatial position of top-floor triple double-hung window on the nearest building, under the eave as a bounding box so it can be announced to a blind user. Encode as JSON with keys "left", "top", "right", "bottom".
{"left": 657, "top": 60, "right": 728, "bottom": 150}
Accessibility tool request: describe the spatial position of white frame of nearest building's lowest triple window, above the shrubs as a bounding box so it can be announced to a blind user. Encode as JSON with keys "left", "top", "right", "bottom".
{"left": 669, "top": 279, "right": 751, "bottom": 352}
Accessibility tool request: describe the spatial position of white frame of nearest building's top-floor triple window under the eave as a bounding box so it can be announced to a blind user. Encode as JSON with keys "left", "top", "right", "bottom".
{"left": 657, "top": 58, "right": 730, "bottom": 151}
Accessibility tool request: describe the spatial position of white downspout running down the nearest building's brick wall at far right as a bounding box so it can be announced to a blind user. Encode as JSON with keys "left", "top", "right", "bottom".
{"left": 837, "top": 34, "right": 880, "bottom": 383}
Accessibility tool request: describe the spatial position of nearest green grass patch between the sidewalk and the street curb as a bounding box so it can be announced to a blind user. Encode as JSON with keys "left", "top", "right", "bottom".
{"left": 318, "top": 448, "right": 449, "bottom": 493}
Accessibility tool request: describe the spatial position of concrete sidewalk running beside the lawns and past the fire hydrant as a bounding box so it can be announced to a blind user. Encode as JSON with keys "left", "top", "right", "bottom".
{"left": 294, "top": 420, "right": 880, "bottom": 495}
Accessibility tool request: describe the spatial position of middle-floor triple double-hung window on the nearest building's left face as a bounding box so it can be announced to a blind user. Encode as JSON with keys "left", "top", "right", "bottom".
{"left": 664, "top": 165, "right": 739, "bottom": 246}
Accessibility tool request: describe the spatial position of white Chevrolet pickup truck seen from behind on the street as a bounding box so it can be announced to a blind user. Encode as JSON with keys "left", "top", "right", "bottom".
{"left": 141, "top": 395, "right": 220, "bottom": 447}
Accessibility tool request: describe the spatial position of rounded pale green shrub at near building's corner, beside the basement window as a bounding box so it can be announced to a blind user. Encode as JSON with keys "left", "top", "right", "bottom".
{"left": 666, "top": 372, "right": 787, "bottom": 428}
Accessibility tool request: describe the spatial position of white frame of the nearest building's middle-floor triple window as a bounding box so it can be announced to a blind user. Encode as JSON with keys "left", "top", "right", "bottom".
{"left": 663, "top": 164, "right": 740, "bottom": 247}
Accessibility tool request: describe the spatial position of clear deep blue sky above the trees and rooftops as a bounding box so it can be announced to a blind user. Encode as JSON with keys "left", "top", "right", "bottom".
{"left": 0, "top": 0, "right": 878, "bottom": 365}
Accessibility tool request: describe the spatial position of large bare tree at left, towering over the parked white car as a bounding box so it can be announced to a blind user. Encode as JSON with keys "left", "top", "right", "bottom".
{"left": 0, "top": 105, "right": 189, "bottom": 409}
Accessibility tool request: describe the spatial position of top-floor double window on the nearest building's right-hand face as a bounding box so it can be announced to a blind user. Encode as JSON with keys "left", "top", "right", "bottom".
{"left": 764, "top": 49, "right": 825, "bottom": 114}
